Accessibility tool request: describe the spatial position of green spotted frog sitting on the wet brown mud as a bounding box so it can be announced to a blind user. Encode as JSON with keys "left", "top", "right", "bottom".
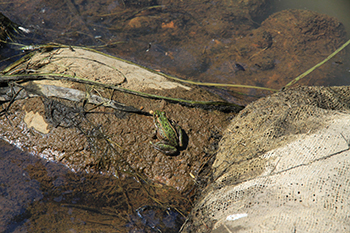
{"left": 151, "top": 110, "right": 183, "bottom": 155}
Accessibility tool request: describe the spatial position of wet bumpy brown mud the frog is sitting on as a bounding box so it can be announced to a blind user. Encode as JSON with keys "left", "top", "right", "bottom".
{"left": 1, "top": 82, "right": 230, "bottom": 192}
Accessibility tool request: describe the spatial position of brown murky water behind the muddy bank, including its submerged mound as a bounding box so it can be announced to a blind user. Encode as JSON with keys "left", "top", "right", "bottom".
{"left": 0, "top": 0, "right": 350, "bottom": 97}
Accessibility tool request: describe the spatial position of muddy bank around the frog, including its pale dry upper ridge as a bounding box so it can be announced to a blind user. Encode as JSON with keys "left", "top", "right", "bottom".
{"left": 1, "top": 48, "right": 239, "bottom": 195}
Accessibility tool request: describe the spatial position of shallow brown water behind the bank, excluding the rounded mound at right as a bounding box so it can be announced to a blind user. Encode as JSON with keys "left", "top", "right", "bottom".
{"left": 0, "top": 0, "right": 350, "bottom": 90}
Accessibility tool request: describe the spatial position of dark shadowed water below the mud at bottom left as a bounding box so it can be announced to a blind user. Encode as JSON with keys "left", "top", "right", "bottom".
{"left": 0, "top": 140, "right": 184, "bottom": 232}
